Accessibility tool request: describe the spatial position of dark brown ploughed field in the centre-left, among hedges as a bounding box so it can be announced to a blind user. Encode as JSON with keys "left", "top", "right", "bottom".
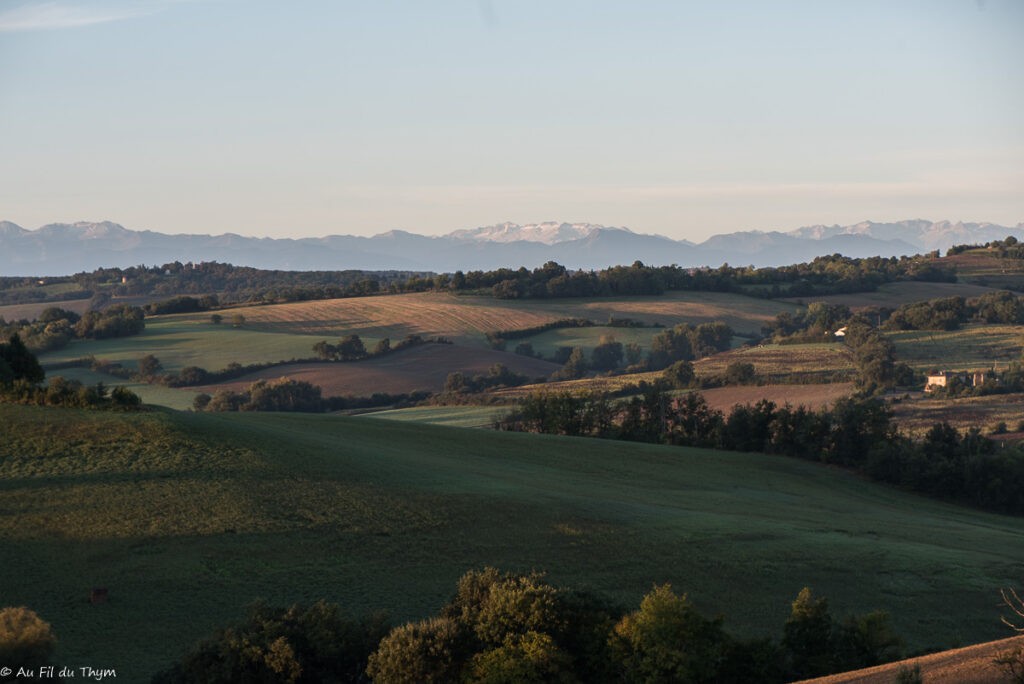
{"left": 193, "top": 344, "right": 559, "bottom": 396}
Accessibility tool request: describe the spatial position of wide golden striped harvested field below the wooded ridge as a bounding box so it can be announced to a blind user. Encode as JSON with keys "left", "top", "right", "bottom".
{"left": 231, "top": 292, "right": 797, "bottom": 345}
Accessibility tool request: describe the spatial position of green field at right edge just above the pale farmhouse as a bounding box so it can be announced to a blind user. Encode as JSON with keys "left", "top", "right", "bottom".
{"left": 887, "top": 325, "right": 1024, "bottom": 371}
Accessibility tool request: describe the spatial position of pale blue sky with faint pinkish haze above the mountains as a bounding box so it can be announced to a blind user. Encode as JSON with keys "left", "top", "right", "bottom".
{"left": 0, "top": 0, "right": 1024, "bottom": 241}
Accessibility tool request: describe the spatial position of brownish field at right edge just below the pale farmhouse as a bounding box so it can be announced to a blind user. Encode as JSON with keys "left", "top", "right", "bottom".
{"left": 892, "top": 393, "right": 1024, "bottom": 434}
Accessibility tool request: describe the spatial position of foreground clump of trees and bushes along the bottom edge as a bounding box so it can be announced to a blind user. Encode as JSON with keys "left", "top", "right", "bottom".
{"left": 142, "top": 567, "right": 903, "bottom": 684}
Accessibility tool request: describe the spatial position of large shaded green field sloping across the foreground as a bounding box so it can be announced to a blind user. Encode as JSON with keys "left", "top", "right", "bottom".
{"left": 0, "top": 405, "right": 1024, "bottom": 681}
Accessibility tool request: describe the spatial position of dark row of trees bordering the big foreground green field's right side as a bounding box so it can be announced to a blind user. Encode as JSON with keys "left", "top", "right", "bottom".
{"left": 496, "top": 385, "right": 1024, "bottom": 515}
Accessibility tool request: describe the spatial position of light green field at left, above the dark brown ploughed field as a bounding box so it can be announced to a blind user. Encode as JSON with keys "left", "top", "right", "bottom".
{"left": 39, "top": 314, "right": 331, "bottom": 371}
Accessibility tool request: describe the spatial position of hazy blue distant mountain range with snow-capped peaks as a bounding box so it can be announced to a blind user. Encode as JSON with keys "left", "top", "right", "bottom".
{"left": 0, "top": 219, "right": 1024, "bottom": 275}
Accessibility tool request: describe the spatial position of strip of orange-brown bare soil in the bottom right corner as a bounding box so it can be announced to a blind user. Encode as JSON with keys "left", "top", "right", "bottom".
{"left": 798, "top": 636, "right": 1024, "bottom": 684}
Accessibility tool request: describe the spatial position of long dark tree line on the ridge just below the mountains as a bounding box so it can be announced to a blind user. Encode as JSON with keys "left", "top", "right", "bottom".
{"left": 0, "top": 237, "right": 983, "bottom": 310}
